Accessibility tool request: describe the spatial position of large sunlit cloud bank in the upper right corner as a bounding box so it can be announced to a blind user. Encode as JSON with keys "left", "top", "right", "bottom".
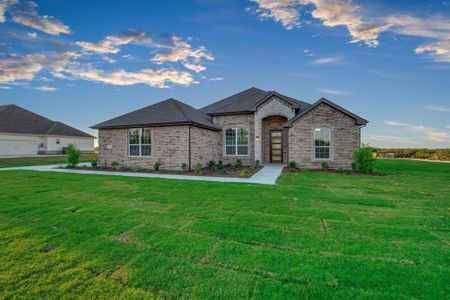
{"left": 247, "top": 0, "right": 450, "bottom": 62}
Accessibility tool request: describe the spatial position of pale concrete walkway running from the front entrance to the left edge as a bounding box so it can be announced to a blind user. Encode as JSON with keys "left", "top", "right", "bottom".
{"left": 0, "top": 163, "right": 283, "bottom": 184}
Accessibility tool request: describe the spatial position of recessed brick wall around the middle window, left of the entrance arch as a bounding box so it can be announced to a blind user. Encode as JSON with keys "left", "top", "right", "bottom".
{"left": 213, "top": 114, "right": 255, "bottom": 165}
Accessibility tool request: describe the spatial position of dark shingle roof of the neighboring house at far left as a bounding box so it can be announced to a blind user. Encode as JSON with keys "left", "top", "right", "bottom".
{"left": 0, "top": 104, "right": 93, "bottom": 138}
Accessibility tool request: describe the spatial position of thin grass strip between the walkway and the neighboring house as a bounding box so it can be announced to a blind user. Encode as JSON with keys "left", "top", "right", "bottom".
{"left": 0, "top": 153, "right": 97, "bottom": 168}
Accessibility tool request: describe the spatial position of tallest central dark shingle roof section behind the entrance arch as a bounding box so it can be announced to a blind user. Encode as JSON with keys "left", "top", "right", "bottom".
{"left": 201, "top": 87, "right": 311, "bottom": 116}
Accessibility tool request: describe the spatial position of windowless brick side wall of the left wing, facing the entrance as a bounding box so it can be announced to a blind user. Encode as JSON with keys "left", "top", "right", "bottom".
{"left": 191, "top": 126, "right": 221, "bottom": 168}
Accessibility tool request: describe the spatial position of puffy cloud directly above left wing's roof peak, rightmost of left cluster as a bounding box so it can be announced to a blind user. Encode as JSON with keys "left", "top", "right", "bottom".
{"left": 151, "top": 36, "right": 214, "bottom": 73}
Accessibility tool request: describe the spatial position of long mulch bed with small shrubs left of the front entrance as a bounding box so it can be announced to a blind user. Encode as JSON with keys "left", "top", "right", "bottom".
{"left": 60, "top": 166, "right": 262, "bottom": 178}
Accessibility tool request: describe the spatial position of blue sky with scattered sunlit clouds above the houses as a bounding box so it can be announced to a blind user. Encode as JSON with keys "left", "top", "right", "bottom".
{"left": 0, "top": 0, "right": 450, "bottom": 148}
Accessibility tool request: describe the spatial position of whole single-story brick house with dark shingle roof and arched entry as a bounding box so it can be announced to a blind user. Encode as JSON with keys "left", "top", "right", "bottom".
{"left": 92, "top": 88, "right": 368, "bottom": 169}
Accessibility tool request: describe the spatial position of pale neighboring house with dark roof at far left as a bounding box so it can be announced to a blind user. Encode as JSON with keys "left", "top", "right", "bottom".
{"left": 0, "top": 104, "right": 95, "bottom": 156}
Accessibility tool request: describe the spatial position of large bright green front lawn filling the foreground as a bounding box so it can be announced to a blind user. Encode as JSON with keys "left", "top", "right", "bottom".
{"left": 0, "top": 160, "right": 450, "bottom": 299}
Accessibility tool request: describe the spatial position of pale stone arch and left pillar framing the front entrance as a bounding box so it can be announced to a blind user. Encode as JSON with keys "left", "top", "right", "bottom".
{"left": 254, "top": 97, "right": 295, "bottom": 161}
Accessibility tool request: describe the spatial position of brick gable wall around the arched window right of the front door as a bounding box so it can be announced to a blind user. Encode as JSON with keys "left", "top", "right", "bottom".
{"left": 288, "top": 104, "right": 360, "bottom": 168}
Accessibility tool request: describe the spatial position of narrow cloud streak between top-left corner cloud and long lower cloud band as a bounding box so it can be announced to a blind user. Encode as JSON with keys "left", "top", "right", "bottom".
{"left": 75, "top": 29, "right": 151, "bottom": 54}
